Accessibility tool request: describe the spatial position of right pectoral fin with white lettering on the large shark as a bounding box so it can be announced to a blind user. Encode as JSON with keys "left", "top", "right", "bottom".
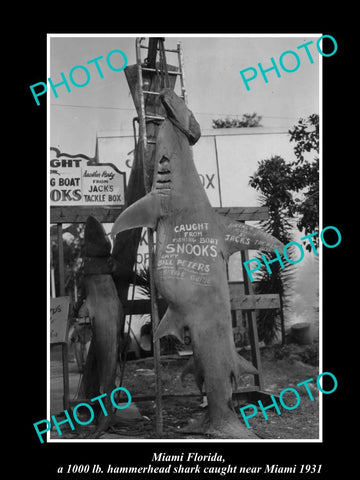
{"left": 219, "top": 215, "right": 284, "bottom": 256}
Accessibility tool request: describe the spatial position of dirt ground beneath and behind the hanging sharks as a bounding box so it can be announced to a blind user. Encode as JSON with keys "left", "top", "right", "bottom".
{"left": 51, "top": 344, "right": 319, "bottom": 440}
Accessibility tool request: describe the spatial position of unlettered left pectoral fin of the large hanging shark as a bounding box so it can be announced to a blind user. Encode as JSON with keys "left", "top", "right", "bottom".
{"left": 111, "top": 192, "right": 161, "bottom": 237}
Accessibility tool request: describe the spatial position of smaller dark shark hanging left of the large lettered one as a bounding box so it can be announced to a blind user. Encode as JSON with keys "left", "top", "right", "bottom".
{"left": 81, "top": 216, "right": 125, "bottom": 436}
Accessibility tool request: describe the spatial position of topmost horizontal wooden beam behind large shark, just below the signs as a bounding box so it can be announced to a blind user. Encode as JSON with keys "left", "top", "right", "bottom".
{"left": 50, "top": 206, "right": 268, "bottom": 223}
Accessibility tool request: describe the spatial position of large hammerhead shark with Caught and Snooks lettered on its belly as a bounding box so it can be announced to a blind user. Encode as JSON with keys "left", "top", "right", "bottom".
{"left": 111, "top": 88, "right": 283, "bottom": 438}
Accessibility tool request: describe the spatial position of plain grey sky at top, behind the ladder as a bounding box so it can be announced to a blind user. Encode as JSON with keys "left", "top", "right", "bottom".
{"left": 48, "top": 32, "right": 322, "bottom": 156}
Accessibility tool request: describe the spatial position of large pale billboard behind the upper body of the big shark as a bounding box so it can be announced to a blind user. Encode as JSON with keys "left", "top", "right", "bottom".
{"left": 97, "top": 127, "right": 296, "bottom": 207}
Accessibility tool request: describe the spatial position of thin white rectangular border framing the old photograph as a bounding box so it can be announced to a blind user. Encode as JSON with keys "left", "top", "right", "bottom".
{"left": 46, "top": 33, "right": 323, "bottom": 444}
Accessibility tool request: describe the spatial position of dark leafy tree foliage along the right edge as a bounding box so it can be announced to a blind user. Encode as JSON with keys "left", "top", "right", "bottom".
{"left": 249, "top": 114, "right": 319, "bottom": 343}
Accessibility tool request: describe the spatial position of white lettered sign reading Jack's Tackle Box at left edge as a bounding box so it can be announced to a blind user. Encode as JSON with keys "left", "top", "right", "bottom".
{"left": 50, "top": 152, "right": 125, "bottom": 206}
